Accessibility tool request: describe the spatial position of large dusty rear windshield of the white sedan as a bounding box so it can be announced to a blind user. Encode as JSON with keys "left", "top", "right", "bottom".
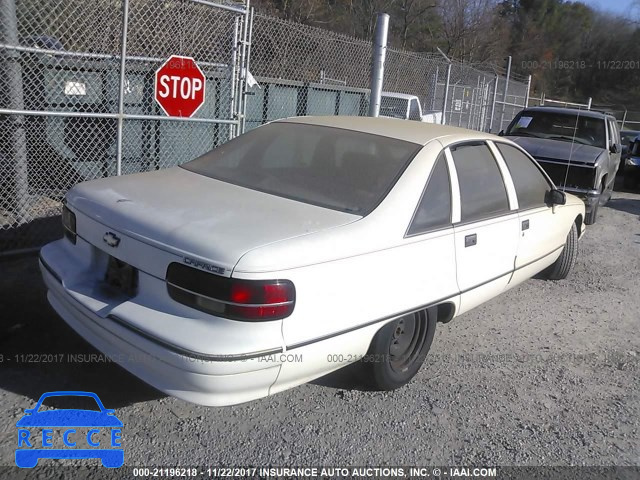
{"left": 182, "top": 122, "right": 421, "bottom": 215}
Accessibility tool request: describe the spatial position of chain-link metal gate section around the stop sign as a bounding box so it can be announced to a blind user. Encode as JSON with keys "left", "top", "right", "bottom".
{"left": 0, "top": 0, "right": 252, "bottom": 255}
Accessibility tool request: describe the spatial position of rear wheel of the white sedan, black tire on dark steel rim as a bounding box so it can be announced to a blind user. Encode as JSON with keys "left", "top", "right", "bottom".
{"left": 362, "top": 307, "right": 437, "bottom": 390}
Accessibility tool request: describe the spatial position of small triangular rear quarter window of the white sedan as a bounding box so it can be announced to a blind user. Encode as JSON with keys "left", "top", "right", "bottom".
{"left": 407, "top": 155, "right": 451, "bottom": 235}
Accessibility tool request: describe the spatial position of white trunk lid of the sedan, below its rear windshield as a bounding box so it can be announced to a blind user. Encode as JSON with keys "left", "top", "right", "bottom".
{"left": 67, "top": 167, "right": 361, "bottom": 276}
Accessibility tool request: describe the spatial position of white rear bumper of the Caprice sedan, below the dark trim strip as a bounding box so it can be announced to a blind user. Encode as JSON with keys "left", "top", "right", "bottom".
{"left": 40, "top": 255, "right": 281, "bottom": 406}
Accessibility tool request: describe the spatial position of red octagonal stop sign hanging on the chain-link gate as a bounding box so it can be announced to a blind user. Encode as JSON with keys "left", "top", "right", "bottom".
{"left": 155, "top": 55, "right": 206, "bottom": 117}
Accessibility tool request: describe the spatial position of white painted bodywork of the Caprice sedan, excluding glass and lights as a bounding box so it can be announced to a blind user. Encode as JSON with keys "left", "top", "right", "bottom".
{"left": 41, "top": 117, "right": 584, "bottom": 405}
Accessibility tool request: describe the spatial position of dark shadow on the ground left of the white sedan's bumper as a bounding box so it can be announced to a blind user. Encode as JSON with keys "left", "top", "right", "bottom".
{"left": 0, "top": 256, "right": 165, "bottom": 408}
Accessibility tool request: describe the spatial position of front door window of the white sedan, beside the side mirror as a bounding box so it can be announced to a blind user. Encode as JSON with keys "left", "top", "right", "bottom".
{"left": 496, "top": 143, "right": 551, "bottom": 209}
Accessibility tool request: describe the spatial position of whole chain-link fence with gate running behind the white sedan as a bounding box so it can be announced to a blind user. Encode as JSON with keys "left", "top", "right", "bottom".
{"left": 0, "top": 0, "right": 528, "bottom": 255}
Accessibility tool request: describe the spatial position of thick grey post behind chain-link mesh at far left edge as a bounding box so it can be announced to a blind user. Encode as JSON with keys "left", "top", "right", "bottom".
{"left": 0, "top": 0, "right": 29, "bottom": 224}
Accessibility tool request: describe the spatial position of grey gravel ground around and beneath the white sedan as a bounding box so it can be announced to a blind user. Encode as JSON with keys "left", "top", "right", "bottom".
{"left": 0, "top": 184, "right": 640, "bottom": 472}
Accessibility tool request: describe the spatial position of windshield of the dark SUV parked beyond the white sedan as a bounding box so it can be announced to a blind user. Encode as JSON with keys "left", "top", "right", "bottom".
{"left": 506, "top": 111, "right": 606, "bottom": 148}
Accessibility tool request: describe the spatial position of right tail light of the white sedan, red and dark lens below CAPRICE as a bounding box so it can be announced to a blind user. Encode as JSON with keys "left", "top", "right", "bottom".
{"left": 167, "top": 263, "right": 295, "bottom": 322}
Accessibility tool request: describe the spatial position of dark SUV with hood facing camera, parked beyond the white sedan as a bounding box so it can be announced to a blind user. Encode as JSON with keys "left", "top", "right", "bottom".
{"left": 501, "top": 107, "right": 622, "bottom": 225}
